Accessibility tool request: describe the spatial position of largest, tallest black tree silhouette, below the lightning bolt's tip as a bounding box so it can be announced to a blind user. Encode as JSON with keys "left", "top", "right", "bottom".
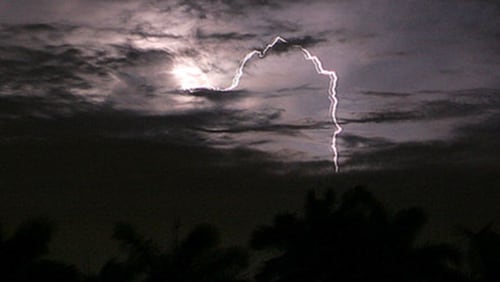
{"left": 251, "top": 187, "right": 462, "bottom": 282}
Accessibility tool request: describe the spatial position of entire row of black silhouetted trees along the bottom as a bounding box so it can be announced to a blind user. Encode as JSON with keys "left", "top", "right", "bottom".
{"left": 0, "top": 187, "right": 500, "bottom": 282}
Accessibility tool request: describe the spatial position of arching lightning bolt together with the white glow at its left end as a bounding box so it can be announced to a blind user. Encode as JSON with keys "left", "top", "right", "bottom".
{"left": 181, "top": 36, "right": 342, "bottom": 172}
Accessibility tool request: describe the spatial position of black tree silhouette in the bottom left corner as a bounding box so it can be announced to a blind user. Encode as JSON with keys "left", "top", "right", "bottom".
{"left": 0, "top": 218, "right": 79, "bottom": 282}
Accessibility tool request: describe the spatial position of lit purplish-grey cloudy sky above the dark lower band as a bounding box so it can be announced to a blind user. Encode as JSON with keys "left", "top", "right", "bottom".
{"left": 0, "top": 0, "right": 500, "bottom": 170}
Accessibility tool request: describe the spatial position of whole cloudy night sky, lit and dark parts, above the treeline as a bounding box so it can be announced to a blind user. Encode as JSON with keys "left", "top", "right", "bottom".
{"left": 0, "top": 0, "right": 500, "bottom": 267}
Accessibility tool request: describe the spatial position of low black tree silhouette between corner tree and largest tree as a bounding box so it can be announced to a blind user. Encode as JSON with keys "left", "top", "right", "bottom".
{"left": 93, "top": 224, "right": 248, "bottom": 282}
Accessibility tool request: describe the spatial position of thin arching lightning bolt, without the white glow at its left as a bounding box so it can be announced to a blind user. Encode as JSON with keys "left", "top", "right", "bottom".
{"left": 186, "top": 36, "right": 342, "bottom": 172}
